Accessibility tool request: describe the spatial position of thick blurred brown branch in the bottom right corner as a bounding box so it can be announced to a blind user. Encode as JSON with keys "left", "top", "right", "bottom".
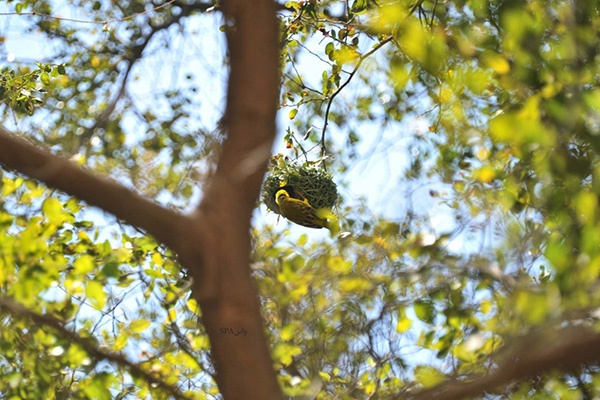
{"left": 404, "top": 326, "right": 600, "bottom": 400}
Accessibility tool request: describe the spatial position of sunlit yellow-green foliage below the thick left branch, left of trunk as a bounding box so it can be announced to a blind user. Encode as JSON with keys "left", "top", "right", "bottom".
{"left": 0, "top": 174, "right": 210, "bottom": 399}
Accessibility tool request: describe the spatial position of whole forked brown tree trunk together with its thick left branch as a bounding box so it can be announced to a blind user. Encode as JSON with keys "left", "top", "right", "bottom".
{"left": 0, "top": 0, "right": 282, "bottom": 400}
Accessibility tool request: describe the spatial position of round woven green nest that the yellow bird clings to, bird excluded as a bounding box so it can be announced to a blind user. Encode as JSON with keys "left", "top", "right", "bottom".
{"left": 262, "top": 165, "right": 338, "bottom": 214}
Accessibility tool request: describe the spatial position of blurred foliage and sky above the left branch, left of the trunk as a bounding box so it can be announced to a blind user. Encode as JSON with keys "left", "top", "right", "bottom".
{"left": 0, "top": 1, "right": 221, "bottom": 207}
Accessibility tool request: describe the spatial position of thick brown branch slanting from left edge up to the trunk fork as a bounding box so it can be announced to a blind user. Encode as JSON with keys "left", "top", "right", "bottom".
{"left": 0, "top": 127, "right": 187, "bottom": 247}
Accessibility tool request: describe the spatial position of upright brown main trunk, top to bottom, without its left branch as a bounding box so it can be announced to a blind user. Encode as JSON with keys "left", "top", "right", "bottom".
{"left": 180, "top": 0, "right": 281, "bottom": 400}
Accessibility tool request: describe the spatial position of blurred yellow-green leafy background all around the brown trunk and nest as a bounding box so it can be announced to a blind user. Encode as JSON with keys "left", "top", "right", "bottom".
{"left": 0, "top": 0, "right": 600, "bottom": 399}
